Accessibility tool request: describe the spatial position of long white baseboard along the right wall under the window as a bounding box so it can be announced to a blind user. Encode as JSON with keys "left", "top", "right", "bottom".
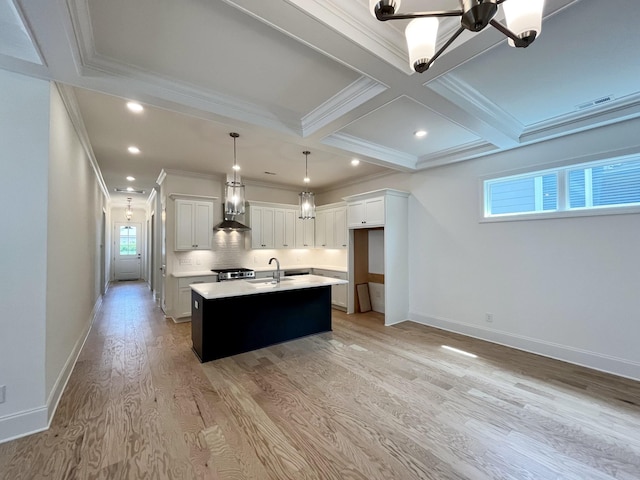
{"left": 409, "top": 312, "right": 640, "bottom": 380}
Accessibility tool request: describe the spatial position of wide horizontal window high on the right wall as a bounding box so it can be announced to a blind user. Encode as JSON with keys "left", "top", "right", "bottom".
{"left": 484, "top": 158, "right": 640, "bottom": 218}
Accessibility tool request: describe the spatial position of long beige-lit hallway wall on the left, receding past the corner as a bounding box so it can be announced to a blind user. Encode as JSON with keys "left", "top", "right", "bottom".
{"left": 46, "top": 84, "right": 105, "bottom": 414}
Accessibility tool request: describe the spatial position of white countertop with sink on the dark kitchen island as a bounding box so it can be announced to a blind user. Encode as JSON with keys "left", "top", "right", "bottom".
{"left": 190, "top": 275, "right": 349, "bottom": 300}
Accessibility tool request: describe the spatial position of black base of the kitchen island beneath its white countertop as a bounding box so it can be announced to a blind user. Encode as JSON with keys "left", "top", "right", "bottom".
{"left": 191, "top": 286, "right": 331, "bottom": 362}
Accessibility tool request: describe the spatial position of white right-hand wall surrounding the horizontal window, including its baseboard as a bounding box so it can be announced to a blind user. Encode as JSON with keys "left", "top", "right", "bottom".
{"left": 409, "top": 121, "right": 640, "bottom": 379}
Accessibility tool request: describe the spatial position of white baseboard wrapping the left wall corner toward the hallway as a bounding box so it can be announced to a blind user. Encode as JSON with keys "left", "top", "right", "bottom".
{"left": 0, "top": 296, "right": 103, "bottom": 443}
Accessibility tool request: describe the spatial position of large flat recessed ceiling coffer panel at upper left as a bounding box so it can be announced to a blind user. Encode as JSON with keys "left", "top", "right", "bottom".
{"left": 89, "top": 0, "right": 360, "bottom": 119}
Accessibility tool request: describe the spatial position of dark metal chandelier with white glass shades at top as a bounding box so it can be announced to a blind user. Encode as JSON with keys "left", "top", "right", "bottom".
{"left": 369, "top": 0, "right": 544, "bottom": 73}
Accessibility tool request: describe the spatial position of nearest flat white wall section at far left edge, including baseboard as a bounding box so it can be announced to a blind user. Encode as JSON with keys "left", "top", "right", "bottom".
{"left": 0, "top": 70, "right": 49, "bottom": 441}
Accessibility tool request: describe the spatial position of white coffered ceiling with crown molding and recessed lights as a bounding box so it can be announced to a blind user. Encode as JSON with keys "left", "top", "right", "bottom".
{"left": 5, "top": 0, "right": 640, "bottom": 207}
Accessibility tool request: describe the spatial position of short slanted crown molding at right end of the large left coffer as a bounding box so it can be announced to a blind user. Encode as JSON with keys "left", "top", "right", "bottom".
{"left": 302, "top": 76, "right": 389, "bottom": 137}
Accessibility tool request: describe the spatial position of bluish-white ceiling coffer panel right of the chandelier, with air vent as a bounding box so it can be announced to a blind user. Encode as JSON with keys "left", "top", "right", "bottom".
{"left": 432, "top": 0, "right": 640, "bottom": 128}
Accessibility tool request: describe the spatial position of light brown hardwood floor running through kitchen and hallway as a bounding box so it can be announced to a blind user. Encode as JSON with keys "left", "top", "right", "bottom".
{"left": 0, "top": 283, "right": 640, "bottom": 480}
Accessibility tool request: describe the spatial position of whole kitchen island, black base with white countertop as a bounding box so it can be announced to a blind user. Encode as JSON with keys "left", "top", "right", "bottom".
{"left": 191, "top": 275, "right": 347, "bottom": 362}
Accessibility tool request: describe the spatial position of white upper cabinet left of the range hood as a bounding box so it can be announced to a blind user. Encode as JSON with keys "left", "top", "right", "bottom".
{"left": 175, "top": 199, "right": 213, "bottom": 250}
